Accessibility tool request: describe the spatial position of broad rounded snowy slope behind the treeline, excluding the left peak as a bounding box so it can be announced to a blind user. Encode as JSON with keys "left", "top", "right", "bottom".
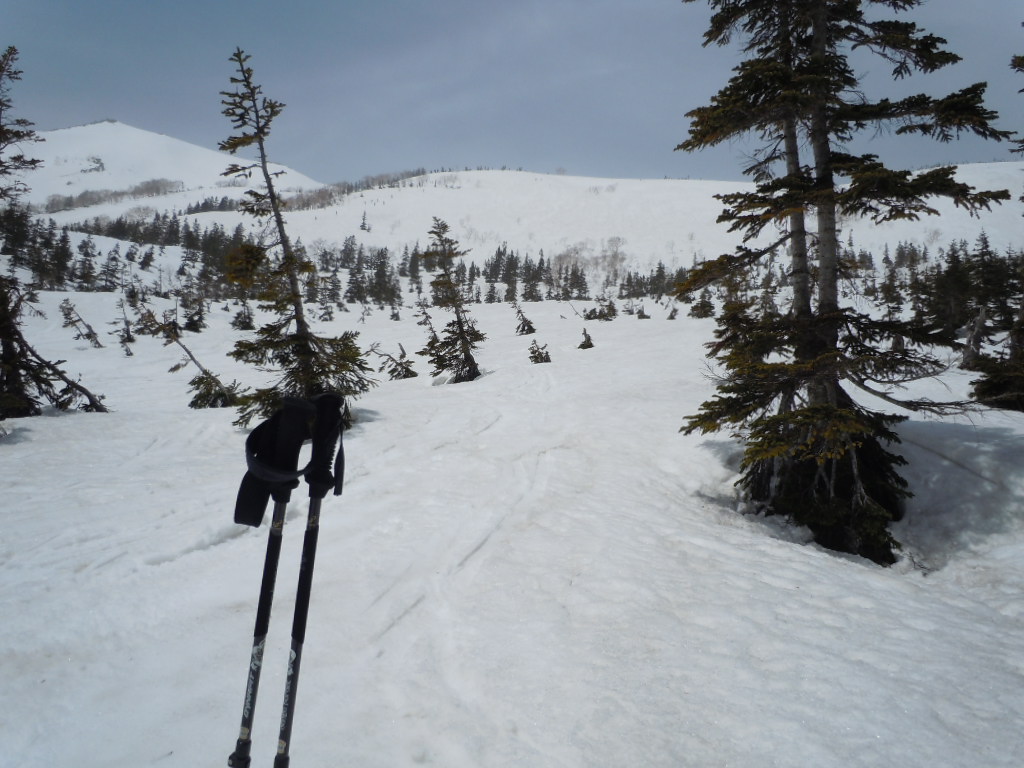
{"left": 270, "top": 162, "right": 1024, "bottom": 270}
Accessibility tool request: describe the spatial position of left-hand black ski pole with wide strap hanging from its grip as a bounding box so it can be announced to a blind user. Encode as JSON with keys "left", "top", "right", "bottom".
{"left": 227, "top": 398, "right": 314, "bottom": 768}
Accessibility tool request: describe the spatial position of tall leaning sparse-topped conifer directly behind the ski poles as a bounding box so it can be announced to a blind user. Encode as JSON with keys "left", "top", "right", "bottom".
{"left": 219, "top": 48, "right": 374, "bottom": 425}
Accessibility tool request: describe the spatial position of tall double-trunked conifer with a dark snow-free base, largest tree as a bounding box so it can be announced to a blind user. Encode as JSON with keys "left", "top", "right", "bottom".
{"left": 677, "top": 0, "right": 1008, "bottom": 564}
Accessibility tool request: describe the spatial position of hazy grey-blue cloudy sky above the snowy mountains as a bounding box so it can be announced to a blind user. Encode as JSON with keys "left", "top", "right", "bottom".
{"left": 8, "top": 0, "right": 1024, "bottom": 182}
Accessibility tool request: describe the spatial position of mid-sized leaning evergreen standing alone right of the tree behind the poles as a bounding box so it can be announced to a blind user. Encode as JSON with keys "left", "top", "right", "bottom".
{"left": 419, "top": 217, "right": 486, "bottom": 384}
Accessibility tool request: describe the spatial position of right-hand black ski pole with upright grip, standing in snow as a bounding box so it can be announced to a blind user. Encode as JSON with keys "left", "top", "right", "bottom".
{"left": 273, "top": 393, "right": 345, "bottom": 768}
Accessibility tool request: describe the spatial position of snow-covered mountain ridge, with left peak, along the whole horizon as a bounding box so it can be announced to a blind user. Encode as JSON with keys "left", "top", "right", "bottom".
{"left": 28, "top": 122, "right": 1024, "bottom": 268}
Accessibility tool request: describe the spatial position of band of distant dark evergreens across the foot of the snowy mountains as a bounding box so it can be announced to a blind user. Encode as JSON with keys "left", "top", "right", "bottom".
{"left": 6, "top": 198, "right": 1024, "bottom": 367}
